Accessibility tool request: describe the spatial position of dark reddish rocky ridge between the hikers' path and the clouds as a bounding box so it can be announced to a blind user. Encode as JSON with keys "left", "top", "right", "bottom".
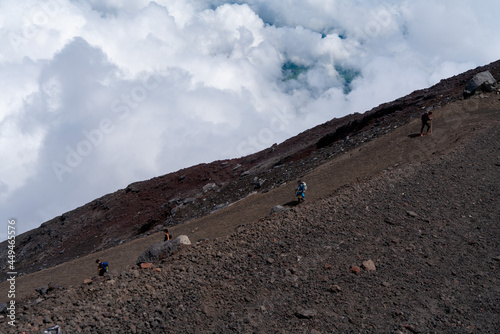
{"left": 0, "top": 61, "right": 500, "bottom": 278}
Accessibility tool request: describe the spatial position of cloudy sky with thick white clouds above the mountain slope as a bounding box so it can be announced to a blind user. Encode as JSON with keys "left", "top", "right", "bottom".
{"left": 0, "top": 0, "right": 500, "bottom": 240}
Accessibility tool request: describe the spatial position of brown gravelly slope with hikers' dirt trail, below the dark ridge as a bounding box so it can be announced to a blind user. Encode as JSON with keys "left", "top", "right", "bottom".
{"left": 0, "top": 90, "right": 500, "bottom": 333}
